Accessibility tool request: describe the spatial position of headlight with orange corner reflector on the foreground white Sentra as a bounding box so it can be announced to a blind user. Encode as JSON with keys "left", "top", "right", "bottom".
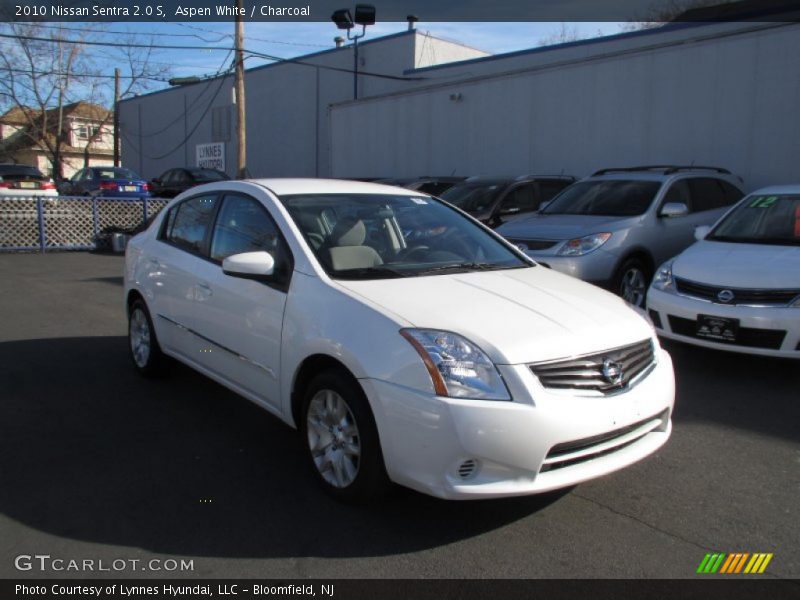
{"left": 400, "top": 329, "right": 511, "bottom": 400}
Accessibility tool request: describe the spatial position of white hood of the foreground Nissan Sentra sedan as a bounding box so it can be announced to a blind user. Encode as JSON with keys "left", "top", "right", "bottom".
{"left": 336, "top": 267, "right": 652, "bottom": 364}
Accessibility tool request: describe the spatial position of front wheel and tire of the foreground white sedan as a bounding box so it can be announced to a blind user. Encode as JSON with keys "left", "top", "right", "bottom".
{"left": 300, "top": 370, "right": 391, "bottom": 503}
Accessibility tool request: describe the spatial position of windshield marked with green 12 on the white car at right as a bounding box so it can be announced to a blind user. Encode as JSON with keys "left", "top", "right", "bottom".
{"left": 706, "top": 194, "right": 800, "bottom": 246}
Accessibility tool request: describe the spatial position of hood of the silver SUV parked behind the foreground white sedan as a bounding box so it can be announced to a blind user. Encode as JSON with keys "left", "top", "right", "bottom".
{"left": 497, "top": 214, "right": 640, "bottom": 240}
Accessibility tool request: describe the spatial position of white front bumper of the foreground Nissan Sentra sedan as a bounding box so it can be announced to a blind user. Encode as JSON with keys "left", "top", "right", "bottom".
{"left": 361, "top": 349, "right": 675, "bottom": 499}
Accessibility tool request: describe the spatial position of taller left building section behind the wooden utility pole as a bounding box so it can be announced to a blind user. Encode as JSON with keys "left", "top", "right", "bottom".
{"left": 120, "top": 32, "right": 484, "bottom": 178}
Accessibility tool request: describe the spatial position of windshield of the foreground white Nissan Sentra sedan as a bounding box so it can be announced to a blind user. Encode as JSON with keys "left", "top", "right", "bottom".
{"left": 281, "top": 194, "right": 535, "bottom": 279}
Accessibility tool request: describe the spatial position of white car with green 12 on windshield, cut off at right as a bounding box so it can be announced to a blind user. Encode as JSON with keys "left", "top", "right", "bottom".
{"left": 647, "top": 185, "right": 800, "bottom": 358}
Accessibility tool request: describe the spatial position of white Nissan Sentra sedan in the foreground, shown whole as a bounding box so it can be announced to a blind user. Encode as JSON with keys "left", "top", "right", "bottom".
{"left": 125, "top": 179, "right": 675, "bottom": 500}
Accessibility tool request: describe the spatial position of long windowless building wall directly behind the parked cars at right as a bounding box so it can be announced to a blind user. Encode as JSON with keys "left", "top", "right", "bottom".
{"left": 331, "top": 24, "right": 800, "bottom": 188}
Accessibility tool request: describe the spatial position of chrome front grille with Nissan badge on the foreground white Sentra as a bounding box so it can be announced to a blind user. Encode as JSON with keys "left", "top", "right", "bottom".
{"left": 530, "top": 340, "right": 655, "bottom": 394}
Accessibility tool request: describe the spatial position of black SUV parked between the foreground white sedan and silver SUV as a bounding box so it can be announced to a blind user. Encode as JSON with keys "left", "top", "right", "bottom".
{"left": 441, "top": 175, "right": 575, "bottom": 227}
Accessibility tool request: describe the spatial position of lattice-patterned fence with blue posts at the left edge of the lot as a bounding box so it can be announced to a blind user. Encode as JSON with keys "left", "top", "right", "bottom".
{"left": 0, "top": 196, "right": 169, "bottom": 252}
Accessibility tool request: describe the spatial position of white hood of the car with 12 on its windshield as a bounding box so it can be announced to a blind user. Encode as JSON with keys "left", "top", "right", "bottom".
{"left": 672, "top": 240, "right": 800, "bottom": 289}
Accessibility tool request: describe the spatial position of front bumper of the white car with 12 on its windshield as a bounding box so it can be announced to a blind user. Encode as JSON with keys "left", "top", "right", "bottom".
{"left": 647, "top": 287, "right": 800, "bottom": 359}
